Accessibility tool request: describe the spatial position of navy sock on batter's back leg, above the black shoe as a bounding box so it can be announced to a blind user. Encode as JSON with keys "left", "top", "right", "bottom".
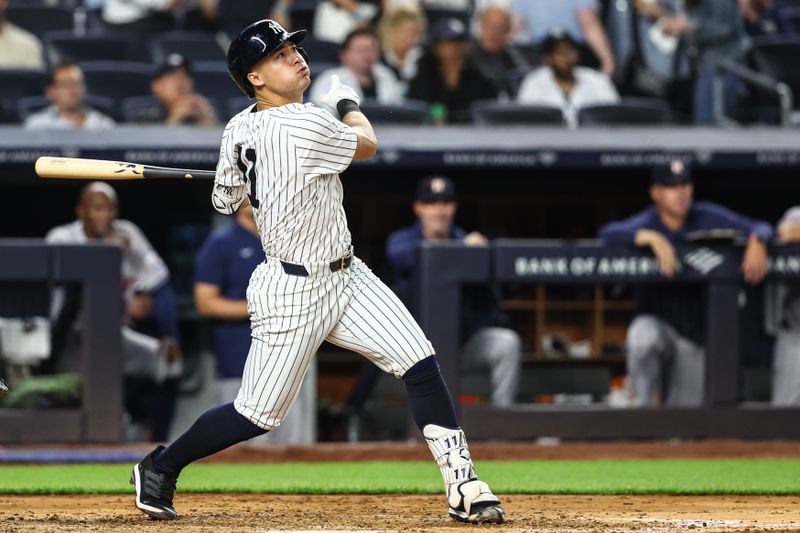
{"left": 155, "top": 403, "right": 267, "bottom": 477}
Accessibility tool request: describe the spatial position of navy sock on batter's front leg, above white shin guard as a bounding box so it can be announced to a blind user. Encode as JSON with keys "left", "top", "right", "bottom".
{"left": 403, "top": 355, "right": 460, "bottom": 431}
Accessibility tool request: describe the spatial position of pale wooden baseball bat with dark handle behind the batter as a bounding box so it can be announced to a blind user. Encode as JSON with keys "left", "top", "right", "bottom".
{"left": 35, "top": 157, "right": 214, "bottom": 180}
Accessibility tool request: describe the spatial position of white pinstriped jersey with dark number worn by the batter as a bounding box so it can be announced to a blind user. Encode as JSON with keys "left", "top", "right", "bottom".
{"left": 215, "top": 104, "right": 357, "bottom": 263}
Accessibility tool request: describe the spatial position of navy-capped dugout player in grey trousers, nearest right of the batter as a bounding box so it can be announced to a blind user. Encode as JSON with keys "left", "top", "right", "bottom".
{"left": 345, "top": 176, "right": 522, "bottom": 424}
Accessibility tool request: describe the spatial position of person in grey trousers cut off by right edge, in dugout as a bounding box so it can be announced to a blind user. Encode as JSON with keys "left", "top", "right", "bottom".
{"left": 772, "top": 206, "right": 800, "bottom": 407}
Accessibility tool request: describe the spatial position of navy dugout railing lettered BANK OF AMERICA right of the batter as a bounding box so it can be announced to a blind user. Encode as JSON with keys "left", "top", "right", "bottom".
{"left": 415, "top": 240, "right": 800, "bottom": 439}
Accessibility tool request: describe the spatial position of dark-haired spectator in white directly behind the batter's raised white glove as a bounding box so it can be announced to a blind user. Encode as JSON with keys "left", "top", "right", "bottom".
{"left": 310, "top": 28, "right": 403, "bottom": 110}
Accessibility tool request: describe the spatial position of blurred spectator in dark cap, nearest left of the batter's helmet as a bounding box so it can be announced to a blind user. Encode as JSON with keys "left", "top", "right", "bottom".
{"left": 136, "top": 54, "right": 218, "bottom": 126}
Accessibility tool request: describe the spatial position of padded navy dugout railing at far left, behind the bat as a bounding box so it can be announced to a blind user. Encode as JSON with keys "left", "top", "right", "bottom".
{"left": 0, "top": 239, "right": 122, "bottom": 444}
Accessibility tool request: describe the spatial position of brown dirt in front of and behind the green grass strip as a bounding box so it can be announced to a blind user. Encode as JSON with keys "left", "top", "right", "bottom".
{"left": 0, "top": 441, "right": 800, "bottom": 533}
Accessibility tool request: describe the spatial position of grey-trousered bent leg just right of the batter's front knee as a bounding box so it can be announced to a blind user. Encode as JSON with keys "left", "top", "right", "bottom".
{"left": 461, "top": 327, "right": 522, "bottom": 406}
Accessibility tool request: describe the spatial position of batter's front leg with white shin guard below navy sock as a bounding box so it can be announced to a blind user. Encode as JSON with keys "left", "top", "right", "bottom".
{"left": 328, "top": 259, "right": 504, "bottom": 523}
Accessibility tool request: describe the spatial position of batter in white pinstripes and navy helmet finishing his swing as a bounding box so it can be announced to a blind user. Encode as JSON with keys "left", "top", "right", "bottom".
{"left": 131, "top": 20, "right": 504, "bottom": 523}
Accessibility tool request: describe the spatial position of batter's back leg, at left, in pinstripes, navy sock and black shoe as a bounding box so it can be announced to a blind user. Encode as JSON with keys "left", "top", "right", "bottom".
{"left": 131, "top": 260, "right": 336, "bottom": 519}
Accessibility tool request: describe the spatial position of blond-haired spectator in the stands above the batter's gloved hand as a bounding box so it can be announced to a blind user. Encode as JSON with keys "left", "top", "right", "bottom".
{"left": 378, "top": 7, "right": 426, "bottom": 89}
